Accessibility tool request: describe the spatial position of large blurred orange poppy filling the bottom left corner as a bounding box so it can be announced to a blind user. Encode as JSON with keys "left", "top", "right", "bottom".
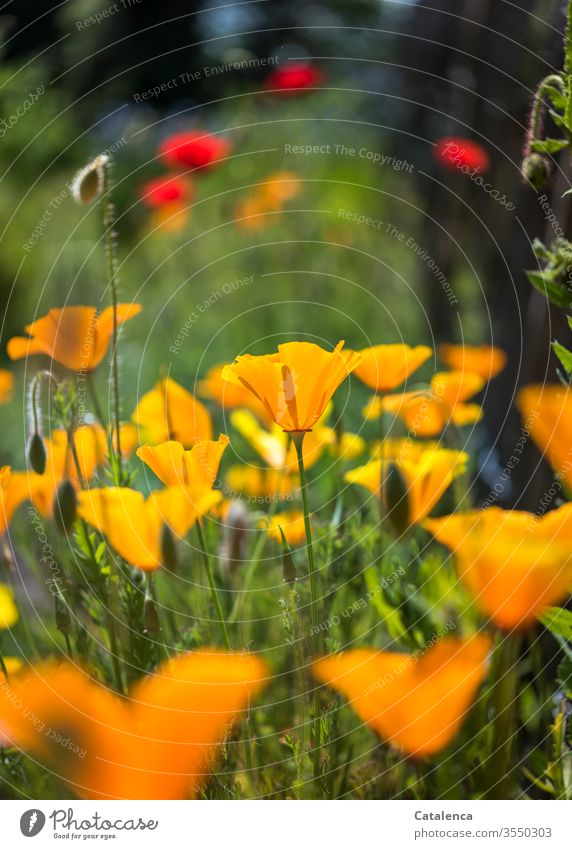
{"left": 0, "top": 650, "right": 267, "bottom": 799}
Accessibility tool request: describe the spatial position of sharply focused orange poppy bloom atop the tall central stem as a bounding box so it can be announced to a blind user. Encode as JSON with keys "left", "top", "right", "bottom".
{"left": 222, "top": 342, "right": 360, "bottom": 432}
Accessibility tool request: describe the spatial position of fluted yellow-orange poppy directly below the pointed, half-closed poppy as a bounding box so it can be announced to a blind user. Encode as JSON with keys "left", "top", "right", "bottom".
{"left": 137, "top": 434, "right": 229, "bottom": 486}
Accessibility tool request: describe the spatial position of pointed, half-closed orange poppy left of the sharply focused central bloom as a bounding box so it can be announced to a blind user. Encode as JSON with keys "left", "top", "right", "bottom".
{"left": 131, "top": 377, "right": 213, "bottom": 448}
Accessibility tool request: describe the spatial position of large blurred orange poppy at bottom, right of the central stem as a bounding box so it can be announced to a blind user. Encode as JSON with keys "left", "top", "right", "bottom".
{"left": 313, "top": 634, "right": 491, "bottom": 757}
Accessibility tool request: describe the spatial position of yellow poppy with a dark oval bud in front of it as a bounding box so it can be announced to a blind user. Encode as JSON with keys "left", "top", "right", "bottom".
{"left": 345, "top": 439, "right": 469, "bottom": 524}
